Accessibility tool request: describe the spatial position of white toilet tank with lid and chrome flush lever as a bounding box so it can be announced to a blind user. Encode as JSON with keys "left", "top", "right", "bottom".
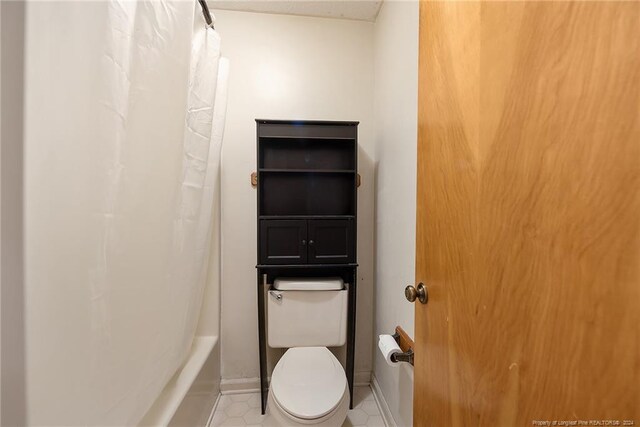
{"left": 267, "top": 278, "right": 347, "bottom": 348}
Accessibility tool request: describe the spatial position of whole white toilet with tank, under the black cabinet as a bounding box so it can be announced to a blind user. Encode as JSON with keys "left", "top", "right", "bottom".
{"left": 267, "top": 278, "right": 349, "bottom": 427}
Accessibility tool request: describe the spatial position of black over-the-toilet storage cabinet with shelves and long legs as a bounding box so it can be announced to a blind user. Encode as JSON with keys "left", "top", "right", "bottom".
{"left": 256, "top": 119, "right": 358, "bottom": 413}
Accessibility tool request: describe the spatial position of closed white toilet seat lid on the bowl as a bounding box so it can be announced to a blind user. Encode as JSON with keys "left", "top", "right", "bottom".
{"left": 271, "top": 347, "right": 348, "bottom": 420}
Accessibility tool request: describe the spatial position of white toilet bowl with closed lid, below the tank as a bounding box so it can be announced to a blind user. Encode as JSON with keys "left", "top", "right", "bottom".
{"left": 267, "top": 347, "right": 349, "bottom": 427}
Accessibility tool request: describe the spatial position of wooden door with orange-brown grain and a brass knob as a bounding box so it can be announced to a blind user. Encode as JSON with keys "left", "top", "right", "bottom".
{"left": 414, "top": 1, "right": 640, "bottom": 426}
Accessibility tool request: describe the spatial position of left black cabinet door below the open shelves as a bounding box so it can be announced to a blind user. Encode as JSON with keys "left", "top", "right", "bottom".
{"left": 260, "top": 219, "right": 307, "bottom": 264}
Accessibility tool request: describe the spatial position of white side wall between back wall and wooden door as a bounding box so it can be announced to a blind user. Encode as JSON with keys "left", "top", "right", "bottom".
{"left": 374, "top": 0, "right": 418, "bottom": 426}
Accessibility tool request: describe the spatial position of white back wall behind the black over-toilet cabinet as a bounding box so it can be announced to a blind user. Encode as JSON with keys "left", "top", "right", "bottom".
{"left": 214, "top": 10, "right": 374, "bottom": 386}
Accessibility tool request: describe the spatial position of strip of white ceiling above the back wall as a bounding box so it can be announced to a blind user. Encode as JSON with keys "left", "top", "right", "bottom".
{"left": 208, "top": 0, "right": 382, "bottom": 22}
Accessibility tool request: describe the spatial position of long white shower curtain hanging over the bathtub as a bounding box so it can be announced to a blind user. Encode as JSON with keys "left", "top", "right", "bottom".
{"left": 24, "top": 1, "right": 227, "bottom": 426}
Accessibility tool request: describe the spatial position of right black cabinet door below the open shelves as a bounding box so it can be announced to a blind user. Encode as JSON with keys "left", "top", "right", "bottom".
{"left": 308, "top": 219, "right": 355, "bottom": 264}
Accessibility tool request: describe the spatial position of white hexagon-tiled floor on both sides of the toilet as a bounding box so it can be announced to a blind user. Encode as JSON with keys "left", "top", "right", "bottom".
{"left": 211, "top": 386, "right": 385, "bottom": 427}
